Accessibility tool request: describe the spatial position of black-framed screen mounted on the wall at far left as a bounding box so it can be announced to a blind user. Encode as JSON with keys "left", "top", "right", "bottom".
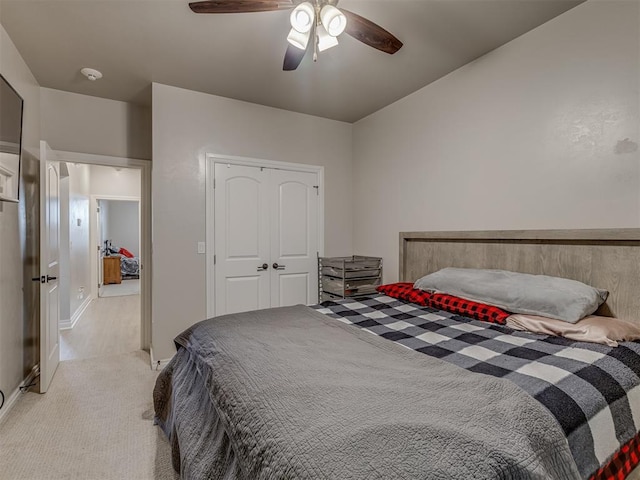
{"left": 0, "top": 75, "right": 24, "bottom": 203}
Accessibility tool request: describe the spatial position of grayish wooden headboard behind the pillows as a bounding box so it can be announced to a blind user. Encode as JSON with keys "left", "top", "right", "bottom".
{"left": 400, "top": 228, "right": 640, "bottom": 324}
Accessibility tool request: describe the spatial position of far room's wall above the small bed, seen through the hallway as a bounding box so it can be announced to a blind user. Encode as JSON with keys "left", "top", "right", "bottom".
{"left": 102, "top": 200, "right": 140, "bottom": 257}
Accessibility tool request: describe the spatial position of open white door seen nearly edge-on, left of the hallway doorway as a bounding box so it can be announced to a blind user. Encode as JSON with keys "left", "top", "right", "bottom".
{"left": 40, "top": 142, "right": 60, "bottom": 393}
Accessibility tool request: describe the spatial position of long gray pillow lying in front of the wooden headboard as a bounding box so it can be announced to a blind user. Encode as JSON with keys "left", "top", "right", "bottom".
{"left": 414, "top": 268, "right": 609, "bottom": 323}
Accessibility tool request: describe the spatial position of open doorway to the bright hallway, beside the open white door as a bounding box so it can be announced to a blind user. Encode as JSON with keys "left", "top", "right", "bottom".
{"left": 55, "top": 160, "right": 148, "bottom": 360}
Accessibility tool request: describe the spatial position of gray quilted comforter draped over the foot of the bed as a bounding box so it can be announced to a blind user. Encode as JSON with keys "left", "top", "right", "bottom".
{"left": 154, "top": 306, "right": 579, "bottom": 480}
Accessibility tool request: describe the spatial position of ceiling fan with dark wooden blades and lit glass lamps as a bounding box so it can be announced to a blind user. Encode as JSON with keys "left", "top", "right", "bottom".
{"left": 189, "top": 0, "right": 402, "bottom": 71}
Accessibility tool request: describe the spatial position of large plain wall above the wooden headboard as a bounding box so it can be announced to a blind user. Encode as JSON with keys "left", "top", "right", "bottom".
{"left": 353, "top": 1, "right": 640, "bottom": 281}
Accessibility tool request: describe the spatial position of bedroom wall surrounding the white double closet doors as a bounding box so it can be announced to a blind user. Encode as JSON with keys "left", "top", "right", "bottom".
{"left": 152, "top": 84, "right": 352, "bottom": 359}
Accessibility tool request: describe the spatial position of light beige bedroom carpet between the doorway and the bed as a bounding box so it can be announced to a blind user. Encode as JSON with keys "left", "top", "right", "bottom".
{"left": 0, "top": 351, "right": 178, "bottom": 480}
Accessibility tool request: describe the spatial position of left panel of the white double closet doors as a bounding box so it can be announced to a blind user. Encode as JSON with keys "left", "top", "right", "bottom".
{"left": 214, "top": 163, "right": 271, "bottom": 316}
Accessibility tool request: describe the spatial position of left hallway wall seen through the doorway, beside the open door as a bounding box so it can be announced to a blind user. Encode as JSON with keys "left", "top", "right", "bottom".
{"left": 69, "top": 164, "right": 92, "bottom": 318}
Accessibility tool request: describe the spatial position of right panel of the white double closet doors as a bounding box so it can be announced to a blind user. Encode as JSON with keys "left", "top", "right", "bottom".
{"left": 270, "top": 170, "right": 319, "bottom": 307}
